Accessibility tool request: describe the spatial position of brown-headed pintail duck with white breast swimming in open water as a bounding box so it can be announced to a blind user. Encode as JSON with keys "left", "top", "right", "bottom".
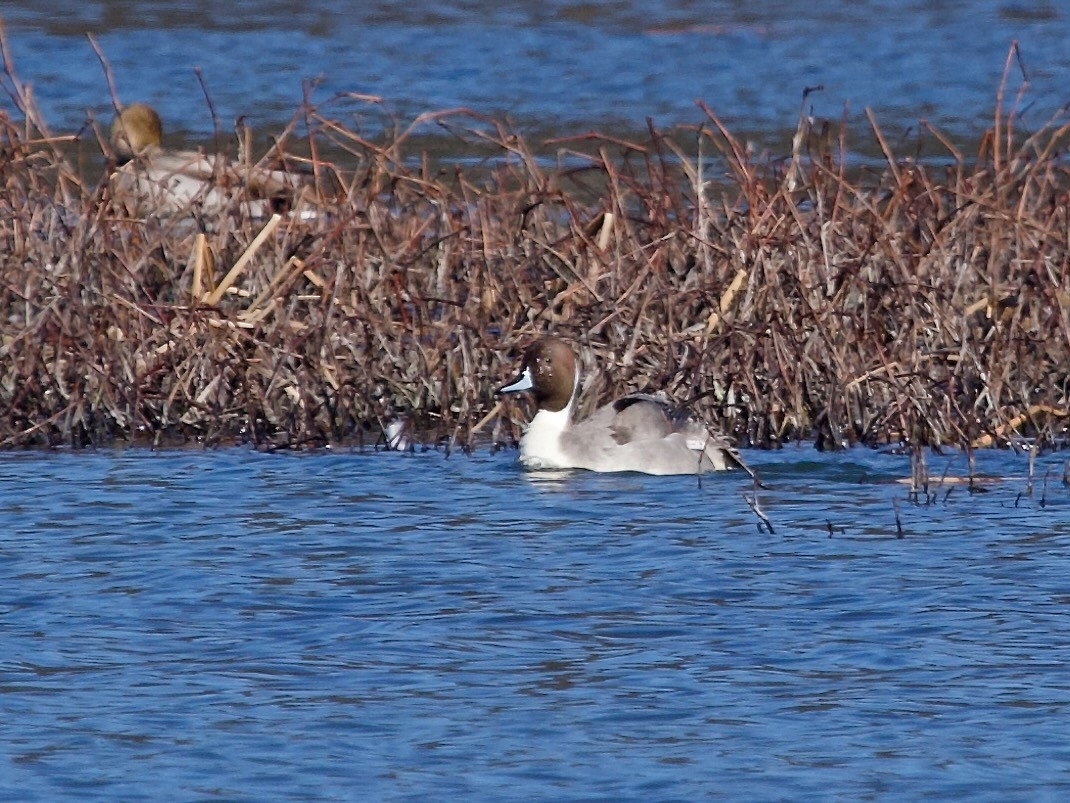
{"left": 499, "top": 337, "right": 753, "bottom": 475}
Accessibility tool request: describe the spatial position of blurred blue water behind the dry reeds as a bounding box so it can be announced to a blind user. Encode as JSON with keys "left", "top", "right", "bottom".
{"left": 0, "top": 0, "right": 1070, "bottom": 157}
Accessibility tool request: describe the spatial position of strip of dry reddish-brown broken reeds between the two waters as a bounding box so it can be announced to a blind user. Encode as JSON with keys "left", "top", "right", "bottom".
{"left": 0, "top": 43, "right": 1070, "bottom": 456}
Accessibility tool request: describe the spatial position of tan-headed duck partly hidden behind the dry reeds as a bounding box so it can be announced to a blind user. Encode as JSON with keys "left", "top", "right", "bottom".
{"left": 110, "top": 103, "right": 308, "bottom": 223}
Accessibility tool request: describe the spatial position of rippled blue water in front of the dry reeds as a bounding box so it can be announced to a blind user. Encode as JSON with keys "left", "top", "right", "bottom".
{"left": 0, "top": 446, "right": 1070, "bottom": 801}
